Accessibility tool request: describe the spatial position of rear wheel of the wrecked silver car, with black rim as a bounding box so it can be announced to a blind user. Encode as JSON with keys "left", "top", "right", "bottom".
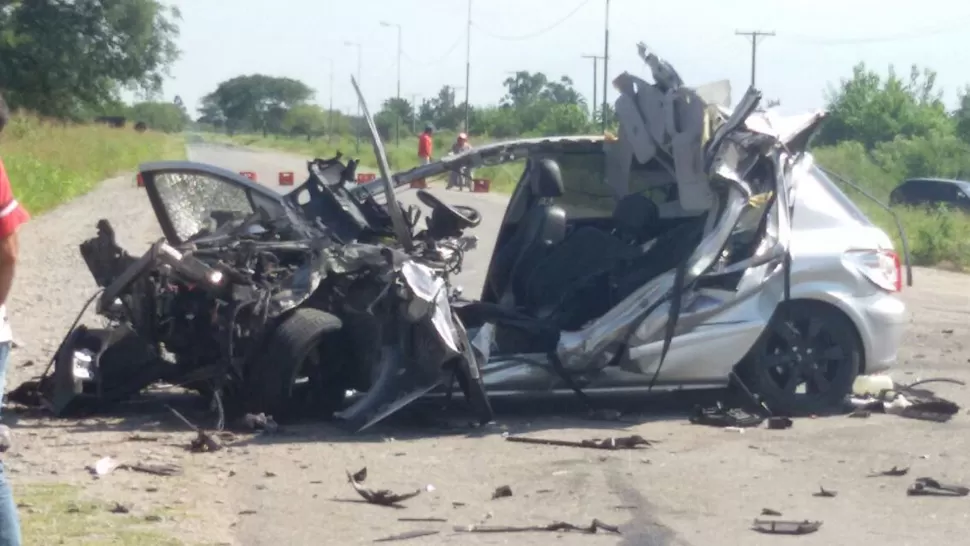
{"left": 739, "top": 300, "right": 864, "bottom": 416}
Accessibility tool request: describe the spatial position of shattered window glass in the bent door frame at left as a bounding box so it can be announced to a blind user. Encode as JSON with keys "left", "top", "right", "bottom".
{"left": 155, "top": 172, "right": 254, "bottom": 241}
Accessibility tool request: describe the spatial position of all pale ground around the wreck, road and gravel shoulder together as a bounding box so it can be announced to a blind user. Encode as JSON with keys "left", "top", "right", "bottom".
{"left": 3, "top": 145, "right": 970, "bottom": 546}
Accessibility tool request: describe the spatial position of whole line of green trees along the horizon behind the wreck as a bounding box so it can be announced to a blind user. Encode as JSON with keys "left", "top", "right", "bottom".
{"left": 0, "top": 0, "right": 970, "bottom": 196}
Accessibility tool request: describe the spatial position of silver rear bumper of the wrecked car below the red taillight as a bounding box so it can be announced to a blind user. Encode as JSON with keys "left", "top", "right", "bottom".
{"left": 853, "top": 293, "right": 909, "bottom": 374}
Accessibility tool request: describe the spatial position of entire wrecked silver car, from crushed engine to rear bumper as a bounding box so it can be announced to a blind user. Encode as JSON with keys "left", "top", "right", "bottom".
{"left": 11, "top": 45, "right": 908, "bottom": 430}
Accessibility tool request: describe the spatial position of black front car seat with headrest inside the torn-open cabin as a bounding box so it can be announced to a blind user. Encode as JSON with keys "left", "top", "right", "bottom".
{"left": 489, "top": 159, "right": 566, "bottom": 303}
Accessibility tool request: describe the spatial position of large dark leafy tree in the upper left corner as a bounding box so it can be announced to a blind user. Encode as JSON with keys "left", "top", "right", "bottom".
{"left": 0, "top": 0, "right": 180, "bottom": 119}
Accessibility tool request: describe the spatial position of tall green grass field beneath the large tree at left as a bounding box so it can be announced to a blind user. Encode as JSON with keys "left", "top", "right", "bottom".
{"left": 0, "top": 116, "right": 185, "bottom": 215}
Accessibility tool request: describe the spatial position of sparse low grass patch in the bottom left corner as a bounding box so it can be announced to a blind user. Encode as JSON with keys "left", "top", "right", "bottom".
{"left": 15, "top": 484, "right": 183, "bottom": 546}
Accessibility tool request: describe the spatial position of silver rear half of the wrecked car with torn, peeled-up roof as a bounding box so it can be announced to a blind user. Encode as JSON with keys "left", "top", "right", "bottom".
{"left": 358, "top": 44, "right": 911, "bottom": 414}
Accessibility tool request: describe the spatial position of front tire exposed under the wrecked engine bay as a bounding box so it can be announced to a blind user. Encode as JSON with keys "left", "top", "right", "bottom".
{"left": 245, "top": 308, "right": 346, "bottom": 421}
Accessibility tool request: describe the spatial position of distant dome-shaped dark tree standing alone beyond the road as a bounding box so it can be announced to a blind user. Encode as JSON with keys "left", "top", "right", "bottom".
{"left": 200, "top": 74, "right": 314, "bottom": 134}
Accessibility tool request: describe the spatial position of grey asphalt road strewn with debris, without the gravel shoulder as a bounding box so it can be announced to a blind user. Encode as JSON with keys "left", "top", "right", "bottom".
{"left": 185, "top": 141, "right": 970, "bottom": 546}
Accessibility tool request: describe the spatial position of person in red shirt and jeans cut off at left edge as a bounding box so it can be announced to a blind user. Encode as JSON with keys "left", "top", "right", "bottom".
{"left": 0, "top": 91, "right": 30, "bottom": 546}
